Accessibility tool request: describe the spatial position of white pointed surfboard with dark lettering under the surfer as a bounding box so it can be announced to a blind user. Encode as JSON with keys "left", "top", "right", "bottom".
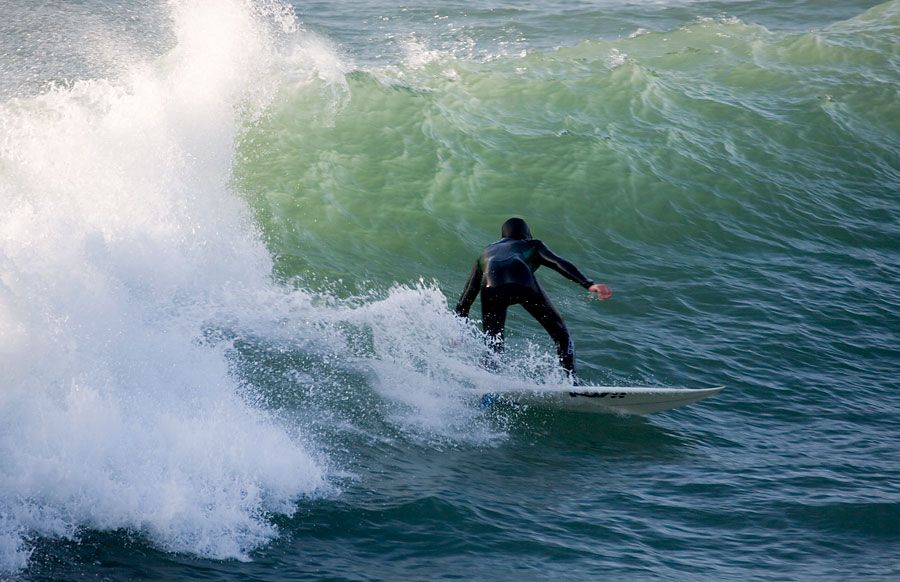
{"left": 481, "top": 385, "right": 724, "bottom": 414}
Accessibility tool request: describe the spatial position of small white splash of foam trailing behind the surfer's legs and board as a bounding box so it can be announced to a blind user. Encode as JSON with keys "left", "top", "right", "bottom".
{"left": 335, "top": 282, "right": 562, "bottom": 445}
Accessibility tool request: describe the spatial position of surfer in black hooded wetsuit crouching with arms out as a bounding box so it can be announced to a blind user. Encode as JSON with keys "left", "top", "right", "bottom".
{"left": 456, "top": 218, "right": 612, "bottom": 381}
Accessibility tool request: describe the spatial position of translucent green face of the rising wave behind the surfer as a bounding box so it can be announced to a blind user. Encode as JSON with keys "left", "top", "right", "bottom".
{"left": 237, "top": 3, "right": 900, "bottom": 289}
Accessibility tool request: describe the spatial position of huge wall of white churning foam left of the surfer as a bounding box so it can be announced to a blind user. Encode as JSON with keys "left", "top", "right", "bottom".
{"left": 0, "top": 0, "right": 334, "bottom": 572}
